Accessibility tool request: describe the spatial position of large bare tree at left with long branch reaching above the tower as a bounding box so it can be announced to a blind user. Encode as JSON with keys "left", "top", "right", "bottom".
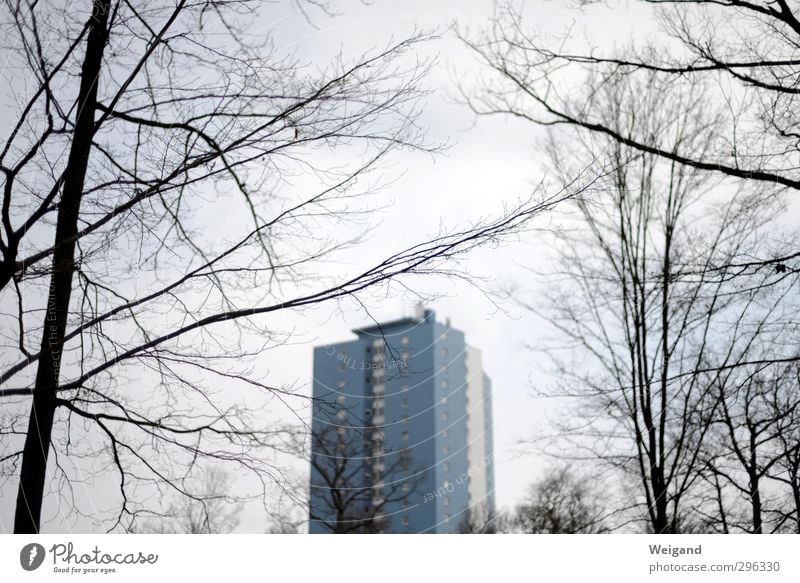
{"left": 0, "top": 0, "right": 580, "bottom": 533}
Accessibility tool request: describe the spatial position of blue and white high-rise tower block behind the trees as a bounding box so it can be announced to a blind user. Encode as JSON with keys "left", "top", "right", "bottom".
{"left": 309, "top": 308, "right": 494, "bottom": 533}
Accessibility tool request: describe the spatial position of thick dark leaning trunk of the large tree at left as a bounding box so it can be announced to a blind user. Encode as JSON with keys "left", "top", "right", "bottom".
{"left": 14, "top": 0, "right": 111, "bottom": 534}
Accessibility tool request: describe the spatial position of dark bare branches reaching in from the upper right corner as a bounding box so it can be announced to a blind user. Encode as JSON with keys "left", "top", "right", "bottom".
{"left": 464, "top": 0, "right": 800, "bottom": 196}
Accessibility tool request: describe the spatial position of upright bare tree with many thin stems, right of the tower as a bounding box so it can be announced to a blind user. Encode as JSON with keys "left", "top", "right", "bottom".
{"left": 532, "top": 140, "right": 797, "bottom": 533}
